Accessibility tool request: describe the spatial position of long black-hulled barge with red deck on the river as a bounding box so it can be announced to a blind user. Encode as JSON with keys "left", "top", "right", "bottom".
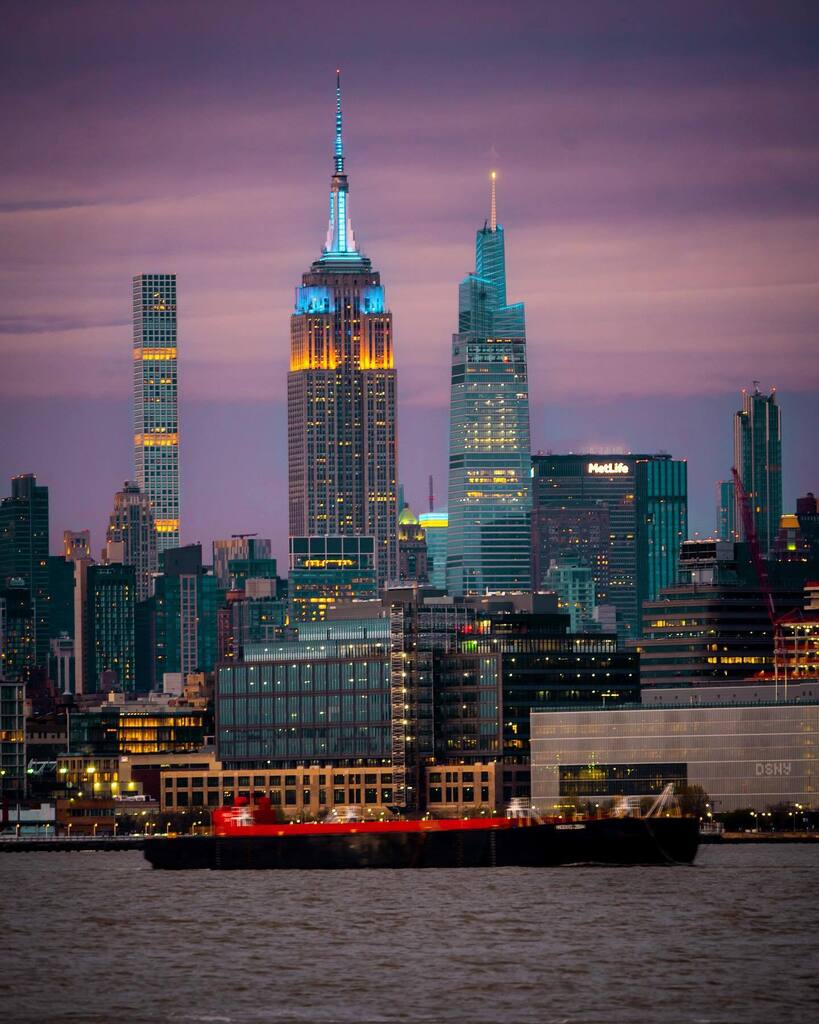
{"left": 144, "top": 798, "right": 699, "bottom": 870}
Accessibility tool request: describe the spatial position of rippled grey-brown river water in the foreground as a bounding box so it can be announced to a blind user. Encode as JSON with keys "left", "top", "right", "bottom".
{"left": 0, "top": 845, "right": 819, "bottom": 1024}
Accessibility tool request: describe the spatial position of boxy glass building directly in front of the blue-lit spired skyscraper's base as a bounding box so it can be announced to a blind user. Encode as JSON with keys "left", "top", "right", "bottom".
{"left": 288, "top": 536, "right": 378, "bottom": 623}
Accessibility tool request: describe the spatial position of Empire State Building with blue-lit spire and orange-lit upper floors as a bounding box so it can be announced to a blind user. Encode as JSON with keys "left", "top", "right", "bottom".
{"left": 288, "top": 75, "right": 398, "bottom": 585}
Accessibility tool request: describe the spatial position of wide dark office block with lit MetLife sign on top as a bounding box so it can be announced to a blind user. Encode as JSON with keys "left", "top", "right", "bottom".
{"left": 531, "top": 453, "right": 688, "bottom": 640}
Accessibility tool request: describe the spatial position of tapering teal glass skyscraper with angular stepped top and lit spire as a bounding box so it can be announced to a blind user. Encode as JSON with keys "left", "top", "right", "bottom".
{"left": 446, "top": 172, "right": 531, "bottom": 595}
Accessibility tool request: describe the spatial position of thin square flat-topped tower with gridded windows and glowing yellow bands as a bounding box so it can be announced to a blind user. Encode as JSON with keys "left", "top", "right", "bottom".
{"left": 133, "top": 273, "right": 179, "bottom": 551}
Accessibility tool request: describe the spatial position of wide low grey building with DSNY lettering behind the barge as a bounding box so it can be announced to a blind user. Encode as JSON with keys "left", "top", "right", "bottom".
{"left": 531, "top": 701, "right": 819, "bottom": 812}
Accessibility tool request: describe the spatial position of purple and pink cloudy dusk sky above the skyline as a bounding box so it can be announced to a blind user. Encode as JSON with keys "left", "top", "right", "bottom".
{"left": 0, "top": 0, "right": 819, "bottom": 557}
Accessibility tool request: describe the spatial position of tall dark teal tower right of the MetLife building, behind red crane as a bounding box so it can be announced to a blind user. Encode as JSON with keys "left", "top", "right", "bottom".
{"left": 734, "top": 381, "right": 782, "bottom": 554}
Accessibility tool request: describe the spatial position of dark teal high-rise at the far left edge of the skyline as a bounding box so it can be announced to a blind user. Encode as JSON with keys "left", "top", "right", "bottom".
{"left": 0, "top": 473, "right": 50, "bottom": 667}
